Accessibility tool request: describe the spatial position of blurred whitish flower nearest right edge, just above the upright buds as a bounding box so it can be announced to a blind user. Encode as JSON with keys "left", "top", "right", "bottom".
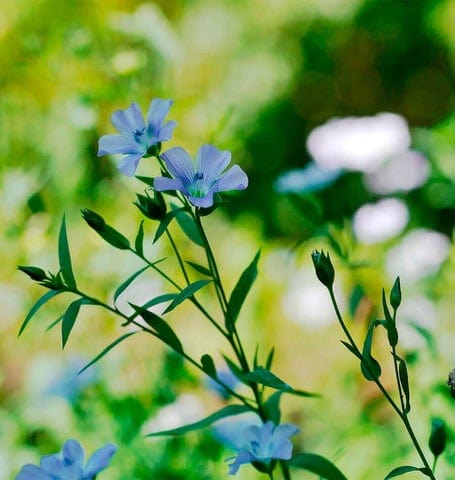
{"left": 386, "top": 228, "right": 450, "bottom": 281}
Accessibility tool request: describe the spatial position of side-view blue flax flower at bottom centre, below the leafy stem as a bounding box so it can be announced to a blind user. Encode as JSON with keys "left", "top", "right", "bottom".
{"left": 228, "top": 421, "right": 299, "bottom": 475}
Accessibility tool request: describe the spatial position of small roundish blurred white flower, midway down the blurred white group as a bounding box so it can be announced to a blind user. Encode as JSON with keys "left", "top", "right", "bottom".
{"left": 353, "top": 198, "right": 409, "bottom": 243}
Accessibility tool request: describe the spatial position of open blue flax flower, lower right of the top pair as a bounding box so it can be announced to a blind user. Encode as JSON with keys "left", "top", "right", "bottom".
{"left": 153, "top": 145, "right": 248, "bottom": 208}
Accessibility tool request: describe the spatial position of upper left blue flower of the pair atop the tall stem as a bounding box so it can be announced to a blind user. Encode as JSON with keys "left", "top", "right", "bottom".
{"left": 98, "top": 98, "right": 177, "bottom": 177}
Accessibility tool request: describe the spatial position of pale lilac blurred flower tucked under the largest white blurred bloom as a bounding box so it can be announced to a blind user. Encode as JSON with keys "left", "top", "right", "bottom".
{"left": 364, "top": 150, "right": 430, "bottom": 195}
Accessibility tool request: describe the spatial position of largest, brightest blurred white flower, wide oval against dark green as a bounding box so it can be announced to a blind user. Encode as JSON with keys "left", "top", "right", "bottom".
{"left": 307, "top": 113, "right": 411, "bottom": 172}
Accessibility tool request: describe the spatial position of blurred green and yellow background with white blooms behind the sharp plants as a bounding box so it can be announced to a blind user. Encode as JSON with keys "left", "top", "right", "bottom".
{"left": 0, "top": 0, "right": 455, "bottom": 480}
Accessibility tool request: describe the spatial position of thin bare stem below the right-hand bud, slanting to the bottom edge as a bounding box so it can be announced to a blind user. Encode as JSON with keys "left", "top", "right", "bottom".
{"left": 328, "top": 287, "right": 436, "bottom": 480}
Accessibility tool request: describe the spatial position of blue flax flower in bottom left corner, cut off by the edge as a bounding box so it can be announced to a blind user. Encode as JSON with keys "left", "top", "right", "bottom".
{"left": 16, "top": 440, "right": 117, "bottom": 480}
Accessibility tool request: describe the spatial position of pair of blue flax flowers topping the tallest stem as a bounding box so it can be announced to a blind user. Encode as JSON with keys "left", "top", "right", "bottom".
{"left": 98, "top": 98, "right": 248, "bottom": 208}
